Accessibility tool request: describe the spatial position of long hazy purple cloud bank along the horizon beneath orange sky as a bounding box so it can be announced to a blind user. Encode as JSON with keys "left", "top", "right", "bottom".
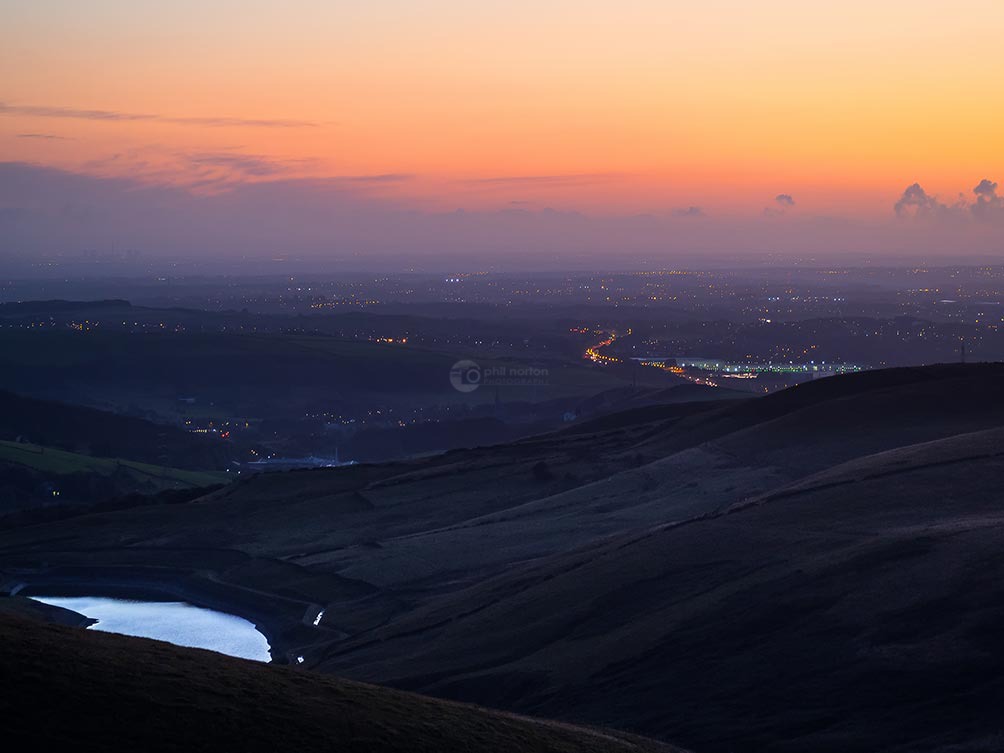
{"left": 0, "top": 161, "right": 1004, "bottom": 269}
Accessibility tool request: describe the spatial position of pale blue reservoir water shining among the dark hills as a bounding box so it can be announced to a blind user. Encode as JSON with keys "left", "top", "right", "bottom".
{"left": 31, "top": 595, "right": 271, "bottom": 662}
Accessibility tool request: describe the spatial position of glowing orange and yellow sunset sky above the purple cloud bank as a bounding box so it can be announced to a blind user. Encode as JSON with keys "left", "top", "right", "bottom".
{"left": 0, "top": 0, "right": 1004, "bottom": 217}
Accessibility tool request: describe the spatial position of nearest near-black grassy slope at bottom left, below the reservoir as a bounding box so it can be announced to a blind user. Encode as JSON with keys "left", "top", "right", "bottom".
{"left": 0, "top": 616, "right": 675, "bottom": 753}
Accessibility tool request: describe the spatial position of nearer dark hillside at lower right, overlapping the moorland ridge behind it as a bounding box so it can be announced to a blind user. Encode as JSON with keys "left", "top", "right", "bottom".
{"left": 326, "top": 383, "right": 1004, "bottom": 753}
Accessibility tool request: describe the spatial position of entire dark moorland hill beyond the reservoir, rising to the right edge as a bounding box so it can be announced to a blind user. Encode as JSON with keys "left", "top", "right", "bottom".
{"left": 0, "top": 364, "right": 1004, "bottom": 753}
